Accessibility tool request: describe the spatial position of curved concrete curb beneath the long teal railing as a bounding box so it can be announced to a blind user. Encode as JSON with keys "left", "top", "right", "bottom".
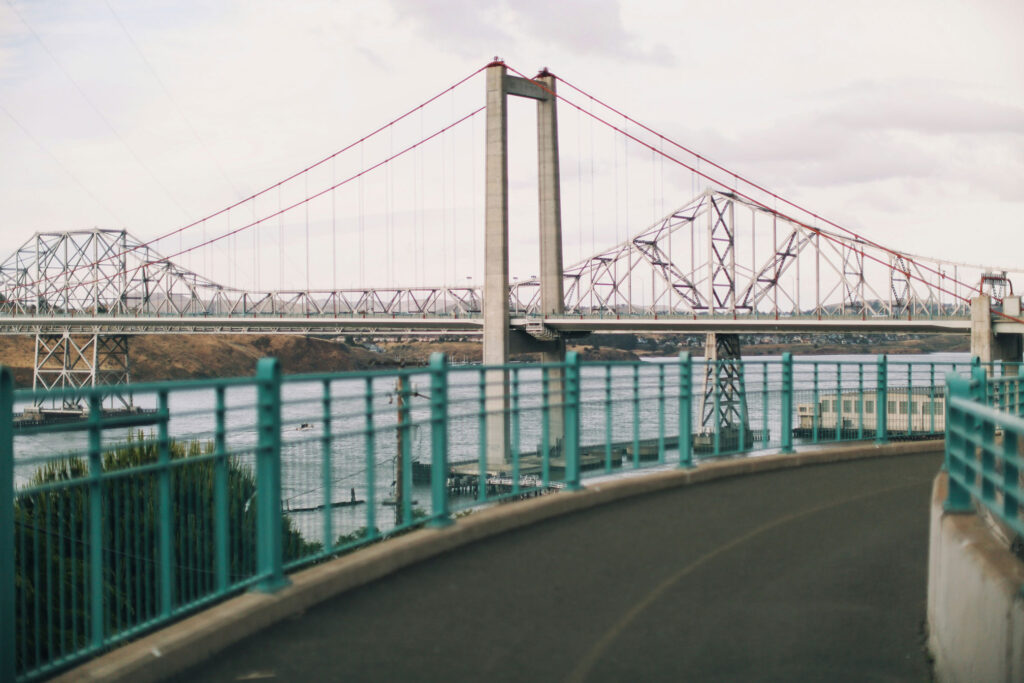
{"left": 54, "top": 440, "right": 943, "bottom": 682}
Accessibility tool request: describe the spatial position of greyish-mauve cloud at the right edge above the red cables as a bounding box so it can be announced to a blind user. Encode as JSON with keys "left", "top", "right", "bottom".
{"left": 667, "top": 83, "right": 1024, "bottom": 199}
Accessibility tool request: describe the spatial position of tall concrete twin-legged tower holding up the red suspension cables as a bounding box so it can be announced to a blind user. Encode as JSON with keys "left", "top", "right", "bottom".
{"left": 483, "top": 60, "right": 565, "bottom": 469}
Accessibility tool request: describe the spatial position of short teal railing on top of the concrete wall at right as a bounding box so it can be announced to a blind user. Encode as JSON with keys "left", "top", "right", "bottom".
{"left": 945, "top": 366, "right": 1024, "bottom": 537}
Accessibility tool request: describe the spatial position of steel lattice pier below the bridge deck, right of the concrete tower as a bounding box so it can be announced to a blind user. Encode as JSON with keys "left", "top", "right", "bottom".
{"left": 697, "top": 332, "right": 754, "bottom": 453}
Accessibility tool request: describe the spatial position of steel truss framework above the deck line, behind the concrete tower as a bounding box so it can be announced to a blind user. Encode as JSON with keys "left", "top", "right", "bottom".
{"left": 0, "top": 198, "right": 1005, "bottom": 327}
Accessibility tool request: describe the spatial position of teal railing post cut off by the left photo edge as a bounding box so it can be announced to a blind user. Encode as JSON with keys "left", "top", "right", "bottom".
{"left": 0, "top": 367, "right": 15, "bottom": 681}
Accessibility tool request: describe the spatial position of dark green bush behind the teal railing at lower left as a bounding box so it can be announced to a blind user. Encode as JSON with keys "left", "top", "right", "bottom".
{"left": 14, "top": 433, "right": 321, "bottom": 671}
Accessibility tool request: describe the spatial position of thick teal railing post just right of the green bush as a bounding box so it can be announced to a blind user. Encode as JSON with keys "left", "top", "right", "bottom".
{"left": 255, "top": 358, "right": 290, "bottom": 593}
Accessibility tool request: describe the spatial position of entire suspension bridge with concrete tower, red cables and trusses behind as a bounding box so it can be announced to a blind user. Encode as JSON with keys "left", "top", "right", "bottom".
{"left": 0, "top": 59, "right": 1024, "bottom": 432}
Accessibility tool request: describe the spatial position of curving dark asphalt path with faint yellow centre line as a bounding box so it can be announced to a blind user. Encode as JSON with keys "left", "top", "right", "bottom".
{"left": 175, "top": 445, "right": 941, "bottom": 682}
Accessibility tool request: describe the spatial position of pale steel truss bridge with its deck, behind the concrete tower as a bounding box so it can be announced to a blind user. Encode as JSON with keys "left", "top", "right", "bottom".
{"left": 0, "top": 190, "right": 1024, "bottom": 335}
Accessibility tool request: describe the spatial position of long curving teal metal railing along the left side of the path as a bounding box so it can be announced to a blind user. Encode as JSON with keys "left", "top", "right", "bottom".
{"left": 0, "top": 353, "right": 1007, "bottom": 681}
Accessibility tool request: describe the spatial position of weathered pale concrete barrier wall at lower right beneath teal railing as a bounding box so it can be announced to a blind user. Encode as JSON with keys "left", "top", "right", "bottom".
{"left": 928, "top": 472, "right": 1024, "bottom": 683}
